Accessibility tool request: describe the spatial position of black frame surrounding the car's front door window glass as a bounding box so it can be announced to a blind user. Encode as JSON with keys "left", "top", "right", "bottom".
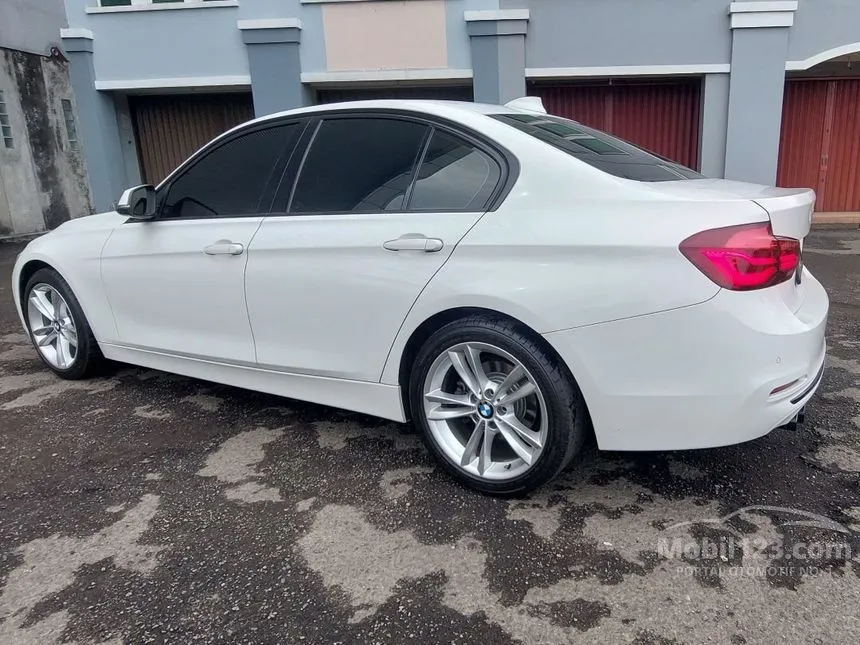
{"left": 149, "top": 116, "right": 308, "bottom": 223}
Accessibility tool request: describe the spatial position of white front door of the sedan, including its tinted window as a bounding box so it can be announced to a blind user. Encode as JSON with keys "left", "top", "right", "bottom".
{"left": 102, "top": 123, "right": 301, "bottom": 364}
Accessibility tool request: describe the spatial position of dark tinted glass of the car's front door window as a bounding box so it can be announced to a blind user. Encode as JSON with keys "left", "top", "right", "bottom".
{"left": 162, "top": 123, "right": 300, "bottom": 217}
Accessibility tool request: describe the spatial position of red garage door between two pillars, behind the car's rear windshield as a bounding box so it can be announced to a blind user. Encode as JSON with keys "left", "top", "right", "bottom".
{"left": 529, "top": 79, "right": 701, "bottom": 168}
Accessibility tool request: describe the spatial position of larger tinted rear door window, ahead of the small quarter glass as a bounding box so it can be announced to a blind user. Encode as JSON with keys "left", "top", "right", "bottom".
{"left": 290, "top": 118, "right": 428, "bottom": 213}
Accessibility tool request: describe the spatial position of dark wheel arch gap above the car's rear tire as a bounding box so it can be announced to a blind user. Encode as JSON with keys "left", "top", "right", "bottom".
{"left": 397, "top": 307, "right": 588, "bottom": 419}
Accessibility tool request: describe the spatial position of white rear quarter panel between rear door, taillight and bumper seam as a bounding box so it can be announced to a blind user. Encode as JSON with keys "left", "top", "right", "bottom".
{"left": 382, "top": 150, "right": 766, "bottom": 383}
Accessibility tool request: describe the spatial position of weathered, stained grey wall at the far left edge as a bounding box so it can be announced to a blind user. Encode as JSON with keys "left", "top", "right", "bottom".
{"left": 0, "top": 0, "right": 91, "bottom": 237}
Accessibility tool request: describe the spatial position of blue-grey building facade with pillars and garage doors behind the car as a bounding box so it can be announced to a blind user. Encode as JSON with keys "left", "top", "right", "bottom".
{"left": 62, "top": 0, "right": 860, "bottom": 216}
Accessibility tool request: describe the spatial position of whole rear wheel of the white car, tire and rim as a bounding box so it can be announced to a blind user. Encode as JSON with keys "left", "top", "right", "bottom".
{"left": 410, "top": 316, "right": 588, "bottom": 494}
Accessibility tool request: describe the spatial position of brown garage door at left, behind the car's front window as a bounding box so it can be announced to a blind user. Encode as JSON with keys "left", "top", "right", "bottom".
{"left": 129, "top": 94, "right": 254, "bottom": 184}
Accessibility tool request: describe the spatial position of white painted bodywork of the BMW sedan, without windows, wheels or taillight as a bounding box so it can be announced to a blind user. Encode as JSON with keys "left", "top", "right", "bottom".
{"left": 13, "top": 101, "right": 828, "bottom": 450}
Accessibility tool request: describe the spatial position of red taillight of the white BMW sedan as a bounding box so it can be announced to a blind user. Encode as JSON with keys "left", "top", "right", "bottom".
{"left": 679, "top": 222, "right": 800, "bottom": 291}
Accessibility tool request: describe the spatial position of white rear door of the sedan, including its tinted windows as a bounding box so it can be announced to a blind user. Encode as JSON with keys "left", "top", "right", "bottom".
{"left": 246, "top": 113, "right": 503, "bottom": 382}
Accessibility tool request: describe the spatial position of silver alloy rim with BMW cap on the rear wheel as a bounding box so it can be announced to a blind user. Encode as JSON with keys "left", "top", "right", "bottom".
{"left": 423, "top": 342, "right": 548, "bottom": 481}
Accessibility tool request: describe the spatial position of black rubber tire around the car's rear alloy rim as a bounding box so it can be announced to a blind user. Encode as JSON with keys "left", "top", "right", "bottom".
{"left": 409, "top": 315, "right": 590, "bottom": 495}
